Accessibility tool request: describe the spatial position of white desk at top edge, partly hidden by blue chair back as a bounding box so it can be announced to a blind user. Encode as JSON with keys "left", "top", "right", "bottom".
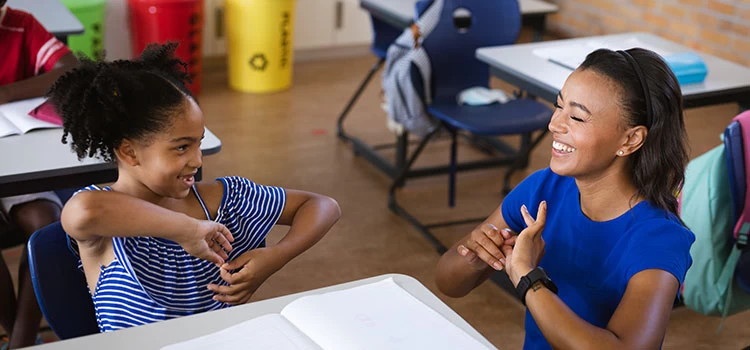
{"left": 360, "top": 0, "right": 559, "bottom": 41}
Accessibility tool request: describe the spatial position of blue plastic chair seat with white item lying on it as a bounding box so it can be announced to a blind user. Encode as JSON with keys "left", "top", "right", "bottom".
{"left": 427, "top": 99, "right": 552, "bottom": 135}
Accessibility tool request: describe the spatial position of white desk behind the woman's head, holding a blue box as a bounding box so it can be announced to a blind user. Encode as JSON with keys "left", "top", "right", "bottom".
{"left": 476, "top": 33, "right": 750, "bottom": 108}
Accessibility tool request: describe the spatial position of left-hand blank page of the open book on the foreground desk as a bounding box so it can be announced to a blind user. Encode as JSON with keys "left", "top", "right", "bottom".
{"left": 161, "top": 314, "right": 321, "bottom": 350}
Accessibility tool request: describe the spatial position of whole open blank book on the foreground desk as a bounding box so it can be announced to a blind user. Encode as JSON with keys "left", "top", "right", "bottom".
{"left": 162, "top": 278, "right": 488, "bottom": 350}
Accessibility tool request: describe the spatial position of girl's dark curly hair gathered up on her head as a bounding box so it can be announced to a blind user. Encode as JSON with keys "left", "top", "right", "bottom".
{"left": 48, "top": 43, "right": 192, "bottom": 161}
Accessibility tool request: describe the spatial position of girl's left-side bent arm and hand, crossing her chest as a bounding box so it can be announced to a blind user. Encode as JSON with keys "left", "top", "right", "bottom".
{"left": 60, "top": 191, "right": 234, "bottom": 264}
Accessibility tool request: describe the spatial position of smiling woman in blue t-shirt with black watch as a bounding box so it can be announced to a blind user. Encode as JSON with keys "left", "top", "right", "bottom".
{"left": 437, "top": 48, "right": 694, "bottom": 349}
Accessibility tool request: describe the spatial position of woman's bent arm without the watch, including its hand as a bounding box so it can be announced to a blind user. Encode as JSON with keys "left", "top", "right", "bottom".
{"left": 435, "top": 205, "right": 514, "bottom": 298}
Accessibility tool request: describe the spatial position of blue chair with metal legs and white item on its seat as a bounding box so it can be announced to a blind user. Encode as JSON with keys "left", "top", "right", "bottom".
{"left": 389, "top": 0, "right": 552, "bottom": 253}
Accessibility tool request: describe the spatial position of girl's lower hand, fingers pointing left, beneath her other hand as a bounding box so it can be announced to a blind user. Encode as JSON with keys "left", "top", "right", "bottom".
{"left": 208, "top": 248, "right": 284, "bottom": 305}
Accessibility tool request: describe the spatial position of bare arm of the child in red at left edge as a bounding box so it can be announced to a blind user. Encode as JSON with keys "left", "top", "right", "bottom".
{"left": 0, "top": 52, "right": 78, "bottom": 104}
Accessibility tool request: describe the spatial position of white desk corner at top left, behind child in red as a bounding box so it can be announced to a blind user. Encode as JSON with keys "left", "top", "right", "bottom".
{"left": 8, "top": 0, "right": 83, "bottom": 41}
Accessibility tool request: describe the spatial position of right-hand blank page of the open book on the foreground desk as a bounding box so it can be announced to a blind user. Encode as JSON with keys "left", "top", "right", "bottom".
{"left": 281, "top": 278, "right": 494, "bottom": 350}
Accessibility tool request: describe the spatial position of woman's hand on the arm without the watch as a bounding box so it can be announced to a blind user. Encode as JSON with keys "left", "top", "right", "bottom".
{"left": 457, "top": 224, "right": 516, "bottom": 270}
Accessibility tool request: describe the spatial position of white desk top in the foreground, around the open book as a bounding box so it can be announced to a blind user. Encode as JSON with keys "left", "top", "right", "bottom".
{"left": 23, "top": 274, "right": 495, "bottom": 350}
